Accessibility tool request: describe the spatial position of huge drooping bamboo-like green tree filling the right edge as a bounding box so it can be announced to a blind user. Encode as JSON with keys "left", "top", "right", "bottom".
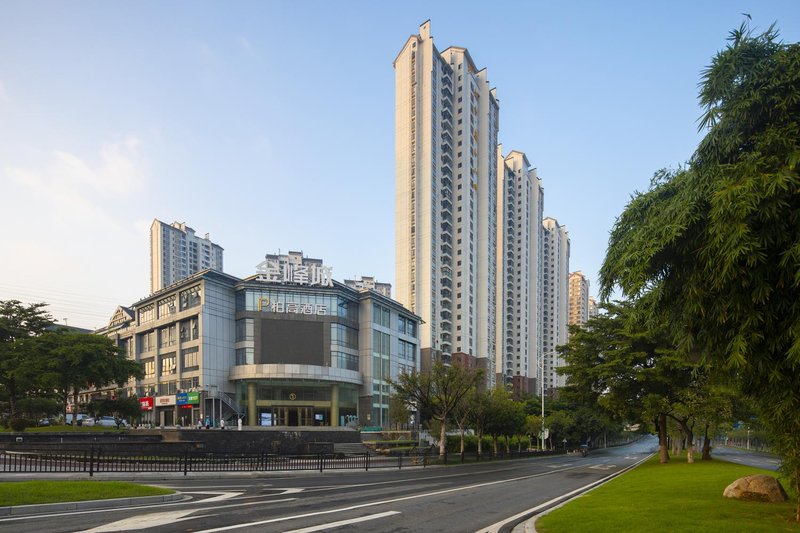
{"left": 600, "top": 25, "right": 800, "bottom": 521}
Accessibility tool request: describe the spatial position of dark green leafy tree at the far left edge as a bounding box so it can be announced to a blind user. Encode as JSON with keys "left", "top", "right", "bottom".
{"left": 0, "top": 300, "right": 53, "bottom": 417}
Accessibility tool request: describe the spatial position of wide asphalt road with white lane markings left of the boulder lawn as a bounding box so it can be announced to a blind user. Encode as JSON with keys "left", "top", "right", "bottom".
{"left": 0, "top": 437, "right": 657, "bottom": 533}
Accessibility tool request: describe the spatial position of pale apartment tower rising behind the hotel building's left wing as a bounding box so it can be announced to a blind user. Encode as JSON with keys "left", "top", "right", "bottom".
{"left": 150, "top": 219, "right": 222, "bottom": 293}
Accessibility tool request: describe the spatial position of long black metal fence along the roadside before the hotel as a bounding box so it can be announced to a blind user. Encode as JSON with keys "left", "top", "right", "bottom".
{"left": 0, "top": 448, "right": 428, "bottom": 476}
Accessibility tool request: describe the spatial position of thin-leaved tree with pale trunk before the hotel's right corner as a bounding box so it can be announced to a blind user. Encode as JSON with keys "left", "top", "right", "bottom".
{"left": 391, "top": 362, "right": 482, "bottom": 456}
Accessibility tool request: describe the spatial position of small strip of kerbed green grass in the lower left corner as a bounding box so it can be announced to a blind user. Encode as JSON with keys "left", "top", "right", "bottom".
{"left": 0, "top": 480, "right": 175, "bottom": 507}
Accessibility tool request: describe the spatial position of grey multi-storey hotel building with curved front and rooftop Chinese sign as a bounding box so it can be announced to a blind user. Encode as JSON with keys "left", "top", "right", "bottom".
{"left": 98, "top": 256, "right": 420, "bottom": 426}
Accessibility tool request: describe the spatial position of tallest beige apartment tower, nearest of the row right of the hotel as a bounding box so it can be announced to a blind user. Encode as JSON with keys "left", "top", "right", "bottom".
{"left": 394, "top": 21, "right": 499, "bottom": 386}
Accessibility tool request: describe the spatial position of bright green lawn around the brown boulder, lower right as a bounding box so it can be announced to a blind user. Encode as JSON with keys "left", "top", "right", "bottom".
{"left": 536, "top": 457, "right": 800, "bottom": 533}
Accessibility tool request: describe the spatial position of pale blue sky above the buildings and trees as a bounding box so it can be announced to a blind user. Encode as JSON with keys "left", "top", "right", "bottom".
{"left": 0, "top": 0, "right": 800, "bottom": 327}
